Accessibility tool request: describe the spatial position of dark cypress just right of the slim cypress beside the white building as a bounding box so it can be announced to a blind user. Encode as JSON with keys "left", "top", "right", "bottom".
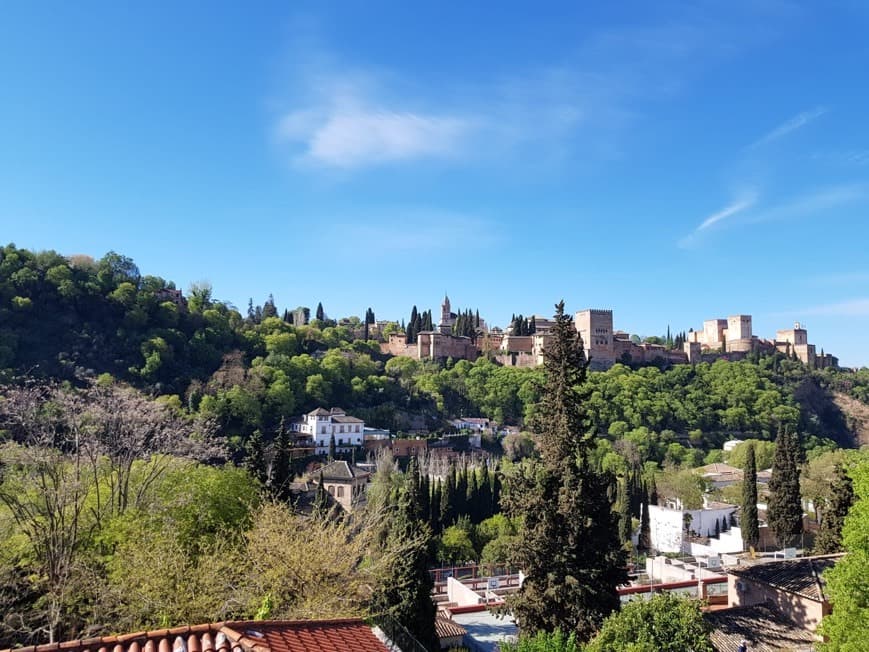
{"left": 768, "top": 428, "right": 803, "bottom": 548}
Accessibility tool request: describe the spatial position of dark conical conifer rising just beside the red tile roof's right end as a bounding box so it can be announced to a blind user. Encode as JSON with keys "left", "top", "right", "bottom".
{"left": 371, "top": 458, "right": 440, "bottom": 650}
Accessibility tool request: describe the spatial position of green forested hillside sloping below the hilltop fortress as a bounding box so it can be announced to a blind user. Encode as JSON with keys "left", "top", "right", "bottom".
{"left": 0, "top": 245, "right": 869, "bottom": 462}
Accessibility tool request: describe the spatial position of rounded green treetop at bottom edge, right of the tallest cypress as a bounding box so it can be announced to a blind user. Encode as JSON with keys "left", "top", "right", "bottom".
{"left": 585, "top": 593, "right": 713, "bottom": 652}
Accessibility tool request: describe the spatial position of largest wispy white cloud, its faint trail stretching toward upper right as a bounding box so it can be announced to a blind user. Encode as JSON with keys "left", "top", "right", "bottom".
{"left": 272, "top": 9, "right": 780, "bottom": 170}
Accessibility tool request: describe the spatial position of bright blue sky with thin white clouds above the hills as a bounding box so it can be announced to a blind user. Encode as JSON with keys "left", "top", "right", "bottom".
{"left": 0, "top": 0, "right": 869, "bottom": 365}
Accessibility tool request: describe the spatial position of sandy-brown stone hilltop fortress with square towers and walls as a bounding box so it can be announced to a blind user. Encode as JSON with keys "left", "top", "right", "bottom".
{"left": 381, "top": 297, "right": 839, "bottom": 370}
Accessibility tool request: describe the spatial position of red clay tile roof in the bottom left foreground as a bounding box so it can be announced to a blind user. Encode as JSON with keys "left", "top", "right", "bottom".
{"left": 2, "top": 618, "right": 388, "bottom": 652}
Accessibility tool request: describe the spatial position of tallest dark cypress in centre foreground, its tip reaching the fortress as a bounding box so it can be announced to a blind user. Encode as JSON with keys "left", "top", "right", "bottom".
{"left": 505, "top": 302, "right": 628, "bottom": 641}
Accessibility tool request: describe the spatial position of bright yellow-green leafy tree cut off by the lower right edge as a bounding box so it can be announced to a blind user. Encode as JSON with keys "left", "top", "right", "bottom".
{"left": 820, "top": 453, "right": 869, "bottom": 652}
